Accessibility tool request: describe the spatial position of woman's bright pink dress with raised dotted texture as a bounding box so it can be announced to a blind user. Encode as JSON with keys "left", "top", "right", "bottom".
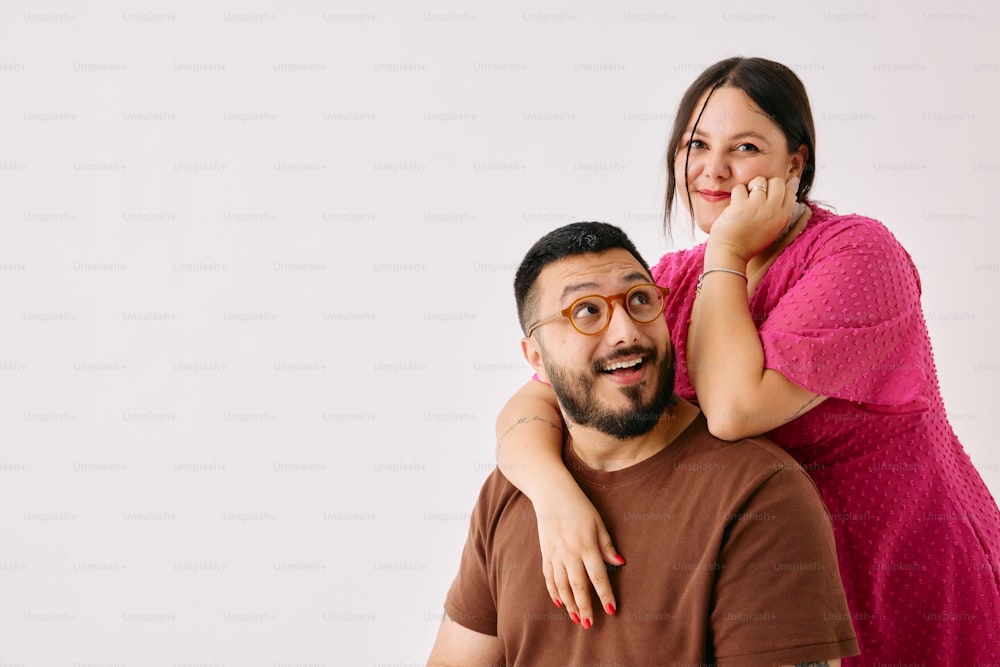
{"left": 653, "top": 205, "right": 1000, "bottom": 666}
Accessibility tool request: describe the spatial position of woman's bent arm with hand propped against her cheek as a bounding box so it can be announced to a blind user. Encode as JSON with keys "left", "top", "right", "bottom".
{"left": 687, "top": 178, "right": 826, "bottom": 440}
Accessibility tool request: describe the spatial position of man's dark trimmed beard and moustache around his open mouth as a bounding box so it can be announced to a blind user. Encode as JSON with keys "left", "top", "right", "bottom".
{"left": 545, "top": 346, "right": 674, "bottom": 440}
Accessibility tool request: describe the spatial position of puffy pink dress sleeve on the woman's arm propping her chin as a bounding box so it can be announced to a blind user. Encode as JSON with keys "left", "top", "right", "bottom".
{"left": 759, "top": 217, "right": 932, "bottom": 411}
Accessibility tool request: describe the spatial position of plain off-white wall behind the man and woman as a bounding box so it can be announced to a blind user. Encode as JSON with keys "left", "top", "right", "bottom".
{"left": 0, "top": 1, "right": 1000, "bottom": 667}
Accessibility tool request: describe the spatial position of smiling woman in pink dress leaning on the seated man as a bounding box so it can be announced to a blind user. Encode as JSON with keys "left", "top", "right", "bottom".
{"left": 497, "top": 58, "right": 1000, "bottom": 665}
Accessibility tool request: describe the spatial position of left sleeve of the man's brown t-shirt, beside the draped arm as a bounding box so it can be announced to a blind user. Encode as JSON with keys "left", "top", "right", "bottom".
{"left": 444, "top": 480, "right": 499, "bottom": 637}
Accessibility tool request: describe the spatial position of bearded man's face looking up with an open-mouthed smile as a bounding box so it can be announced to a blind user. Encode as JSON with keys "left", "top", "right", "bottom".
{"left": 524, "top": 248, "right": 674, "bottom": 439}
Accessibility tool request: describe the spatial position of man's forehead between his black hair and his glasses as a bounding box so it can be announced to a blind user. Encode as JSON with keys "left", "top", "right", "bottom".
{"left": 539, "top": 248, "right": 650, "bottom": 300}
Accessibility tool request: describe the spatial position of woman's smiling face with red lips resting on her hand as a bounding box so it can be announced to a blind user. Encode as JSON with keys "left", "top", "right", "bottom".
{"left": 674, "top": 86, "right": 808, "bottom": 234}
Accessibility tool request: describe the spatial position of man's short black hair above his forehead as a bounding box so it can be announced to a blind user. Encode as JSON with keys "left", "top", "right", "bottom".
{"left": 514, "top": 222, "right": 649, "bottom": 333}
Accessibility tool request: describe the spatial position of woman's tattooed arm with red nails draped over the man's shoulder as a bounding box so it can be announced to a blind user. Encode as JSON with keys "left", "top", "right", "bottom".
{"left": 497, "top": 380, "right": 625, "bottom": 628}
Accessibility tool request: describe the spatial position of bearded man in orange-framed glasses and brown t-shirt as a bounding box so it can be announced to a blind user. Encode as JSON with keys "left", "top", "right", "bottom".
{"left": 429, "top": 223, "right": 857, "bottom": 667}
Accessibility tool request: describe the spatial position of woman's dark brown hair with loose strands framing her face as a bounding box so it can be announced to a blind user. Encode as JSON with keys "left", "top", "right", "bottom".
{"left": 663, "top": 58, "right": 816, "bottom": 233}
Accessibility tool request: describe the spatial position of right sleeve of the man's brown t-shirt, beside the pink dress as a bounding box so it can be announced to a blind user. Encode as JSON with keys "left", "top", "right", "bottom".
{"left": 711, "top": 467, "right": 858, "bottom": 667}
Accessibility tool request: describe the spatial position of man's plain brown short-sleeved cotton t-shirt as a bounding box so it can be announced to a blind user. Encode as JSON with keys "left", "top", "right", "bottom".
{"left": 445, "top": 417, "right": 858, "bottom": 667}
